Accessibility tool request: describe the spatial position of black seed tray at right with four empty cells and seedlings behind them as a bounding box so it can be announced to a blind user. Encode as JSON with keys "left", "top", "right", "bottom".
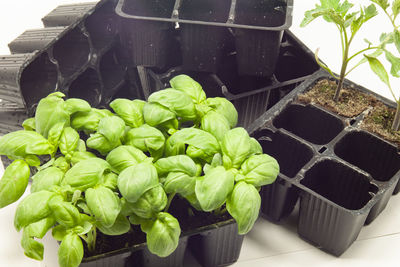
{"left": 249, "top": 70, "right": 400, "bottom": 256}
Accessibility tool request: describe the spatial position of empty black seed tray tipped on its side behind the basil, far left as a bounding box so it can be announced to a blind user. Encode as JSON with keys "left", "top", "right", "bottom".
{"left": 0, "top": 0, "right": 144, "bottom": 115}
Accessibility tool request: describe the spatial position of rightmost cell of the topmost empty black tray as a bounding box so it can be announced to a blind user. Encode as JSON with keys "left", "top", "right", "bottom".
{"left": 234, "top": 0, "right": 291, "bottom": 76}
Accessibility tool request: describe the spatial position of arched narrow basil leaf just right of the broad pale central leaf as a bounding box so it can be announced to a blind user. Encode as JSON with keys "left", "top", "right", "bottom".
{"left": 154, "top": 155, "right": 197, "bottom": 177}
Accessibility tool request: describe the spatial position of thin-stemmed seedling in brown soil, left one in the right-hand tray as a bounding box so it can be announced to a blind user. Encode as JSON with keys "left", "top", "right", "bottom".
{"left": 301, "top": 0, "right": 379, "bottom": 102}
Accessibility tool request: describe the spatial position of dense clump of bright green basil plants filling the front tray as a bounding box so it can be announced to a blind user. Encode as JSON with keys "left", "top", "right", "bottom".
{"left": 0, "top": 75, "right": 279, "bottom": 267}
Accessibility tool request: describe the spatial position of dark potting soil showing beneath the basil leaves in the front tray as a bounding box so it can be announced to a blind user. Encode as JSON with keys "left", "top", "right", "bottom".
{"left": 84, "top": 196, "right": 232, "bottom": 257}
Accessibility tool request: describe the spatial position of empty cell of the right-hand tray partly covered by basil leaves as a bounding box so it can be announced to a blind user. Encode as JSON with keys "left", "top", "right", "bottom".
{"left": 253, "top": 129, "right": 314, "bottom": 223}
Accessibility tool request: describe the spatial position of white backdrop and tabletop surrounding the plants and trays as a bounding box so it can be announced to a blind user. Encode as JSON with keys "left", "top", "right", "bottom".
{"left": 0, "top": 0, "right": 400, "bottom": 267}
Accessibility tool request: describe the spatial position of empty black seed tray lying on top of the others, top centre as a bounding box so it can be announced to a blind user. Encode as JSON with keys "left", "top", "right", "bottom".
{"left": 116, "top": 0, "right": 293, "bottom": 77}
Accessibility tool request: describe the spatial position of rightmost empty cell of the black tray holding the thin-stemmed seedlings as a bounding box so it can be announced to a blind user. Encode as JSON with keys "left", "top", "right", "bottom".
{"left": 335, "top": 131, "right": 400, "bottom": 224}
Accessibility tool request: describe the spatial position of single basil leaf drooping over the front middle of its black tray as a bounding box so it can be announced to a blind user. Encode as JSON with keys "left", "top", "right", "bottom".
{"left": 143, "top": 212, "right": 181, "bottom": 257}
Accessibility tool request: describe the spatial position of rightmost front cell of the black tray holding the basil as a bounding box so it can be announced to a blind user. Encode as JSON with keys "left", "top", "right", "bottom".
{"left": 189, "top": 223, "right": 244, "bottom": 267}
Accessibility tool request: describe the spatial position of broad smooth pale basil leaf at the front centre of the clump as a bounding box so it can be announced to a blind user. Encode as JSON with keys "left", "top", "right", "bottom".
{"left": 118, "top": 163, "right": 158, "bottom": 203}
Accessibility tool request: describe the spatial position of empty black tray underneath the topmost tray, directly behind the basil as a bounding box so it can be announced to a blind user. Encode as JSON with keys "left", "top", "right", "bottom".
{"left": 138, "top": 30, "right": 319, "bottom": 127}
